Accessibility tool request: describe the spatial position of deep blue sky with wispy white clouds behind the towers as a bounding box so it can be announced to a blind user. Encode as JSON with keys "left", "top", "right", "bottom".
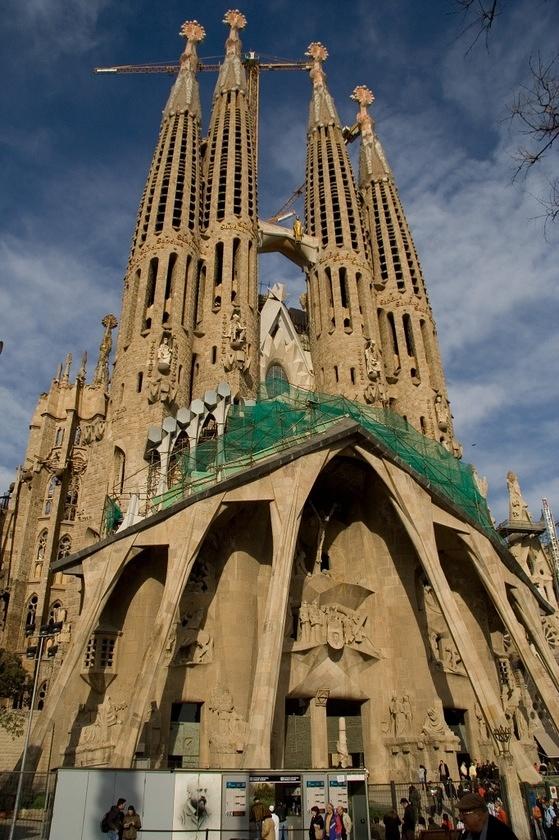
{"left": 0, "top": 0, "right": 559, "bottom": 521}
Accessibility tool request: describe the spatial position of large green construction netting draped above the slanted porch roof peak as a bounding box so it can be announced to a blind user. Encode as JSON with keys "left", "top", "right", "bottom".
{"left": 152, "top": 382, "right": 495, "bottom": 536}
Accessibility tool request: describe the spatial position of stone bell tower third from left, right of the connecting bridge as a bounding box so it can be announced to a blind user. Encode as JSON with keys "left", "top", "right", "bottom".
{"left": 305, "top": 42, "right": 385, "bottom": 405}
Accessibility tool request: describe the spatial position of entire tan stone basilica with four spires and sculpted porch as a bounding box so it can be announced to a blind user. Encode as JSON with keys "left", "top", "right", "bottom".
{"left": 1, "top": 11, "right": 559, "bottom": 826}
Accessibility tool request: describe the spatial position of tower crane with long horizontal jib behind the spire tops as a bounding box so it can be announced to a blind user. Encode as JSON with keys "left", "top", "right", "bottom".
{"left": 93, "top": 50, "right": 312, "bottom": 168}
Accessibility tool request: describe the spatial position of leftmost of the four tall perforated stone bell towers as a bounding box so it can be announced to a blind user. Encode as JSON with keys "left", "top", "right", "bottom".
{"left": 110, "top": 21, "right": 205, "bottom": 486}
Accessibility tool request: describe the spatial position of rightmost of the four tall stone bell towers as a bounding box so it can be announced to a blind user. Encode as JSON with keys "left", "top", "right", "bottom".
{"left": 351, "top": 85, "right": 461, "bottom": 455}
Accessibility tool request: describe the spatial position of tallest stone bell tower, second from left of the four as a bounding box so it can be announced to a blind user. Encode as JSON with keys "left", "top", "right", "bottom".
{"left": 192, "top": 9, "right": 259, "bottom": 397}
